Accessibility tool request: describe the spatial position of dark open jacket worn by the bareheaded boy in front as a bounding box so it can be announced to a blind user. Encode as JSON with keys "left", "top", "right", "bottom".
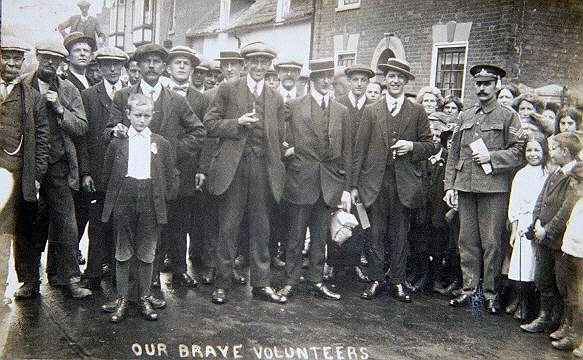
{"left": 101, "top": 133, "right": 177, "bottom": 224}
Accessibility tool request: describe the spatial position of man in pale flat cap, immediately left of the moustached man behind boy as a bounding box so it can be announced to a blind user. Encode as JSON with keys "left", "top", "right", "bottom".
{"left": 79, "top": 47, "right": 128, "bottom": 288}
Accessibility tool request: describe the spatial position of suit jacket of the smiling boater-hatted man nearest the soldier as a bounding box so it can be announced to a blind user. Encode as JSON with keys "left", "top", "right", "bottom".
{"left": 352, "top": 100, "right": 438, "bottom": 209}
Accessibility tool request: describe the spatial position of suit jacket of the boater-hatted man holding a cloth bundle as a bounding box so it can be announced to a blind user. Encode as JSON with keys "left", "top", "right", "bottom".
{"left": 283, "top": 94, "right": 352, "bottom": 207}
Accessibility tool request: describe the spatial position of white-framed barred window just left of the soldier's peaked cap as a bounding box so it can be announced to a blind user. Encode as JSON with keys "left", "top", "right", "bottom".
{"left": 432, "top": 44, "right": 468, "bottom": 99}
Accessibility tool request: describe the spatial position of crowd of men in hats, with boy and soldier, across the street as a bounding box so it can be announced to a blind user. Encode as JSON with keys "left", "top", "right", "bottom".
{"left": 0, "top": 1, "right": 576, "bottom": 356}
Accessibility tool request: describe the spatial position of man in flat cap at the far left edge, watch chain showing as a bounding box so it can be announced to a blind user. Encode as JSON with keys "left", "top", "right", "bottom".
{"left": 0, "top": 34, "right": 50, "bottom": 297}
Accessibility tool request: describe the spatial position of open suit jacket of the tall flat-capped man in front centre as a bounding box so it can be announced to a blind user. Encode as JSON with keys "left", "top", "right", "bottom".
{"left": 204, "top": 77, "right": 285, "bottom": 202}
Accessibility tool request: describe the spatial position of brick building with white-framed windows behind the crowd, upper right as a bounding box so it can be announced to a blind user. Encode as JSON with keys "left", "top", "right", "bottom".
{"left": 312, "top": 0, "right": 583, "bottom": 104}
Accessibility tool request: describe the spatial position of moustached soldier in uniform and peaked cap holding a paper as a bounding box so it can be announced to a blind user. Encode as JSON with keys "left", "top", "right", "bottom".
{"left": 444, "top": 65, "right": 525, "bottom": 314}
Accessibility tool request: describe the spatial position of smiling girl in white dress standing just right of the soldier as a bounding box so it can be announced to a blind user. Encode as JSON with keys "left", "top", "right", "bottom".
{"left": 507, "top": 134, "right": 547, "bottom": 320}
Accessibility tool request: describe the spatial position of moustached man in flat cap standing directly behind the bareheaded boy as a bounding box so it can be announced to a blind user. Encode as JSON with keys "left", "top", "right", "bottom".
{"left": 104, "top": 44, "right": 206, "bottom": 287}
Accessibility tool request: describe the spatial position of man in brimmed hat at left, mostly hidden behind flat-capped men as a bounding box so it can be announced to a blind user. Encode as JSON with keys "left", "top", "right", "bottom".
{"left": 63, "top": 31, "right": 95, "bottom": 265}
